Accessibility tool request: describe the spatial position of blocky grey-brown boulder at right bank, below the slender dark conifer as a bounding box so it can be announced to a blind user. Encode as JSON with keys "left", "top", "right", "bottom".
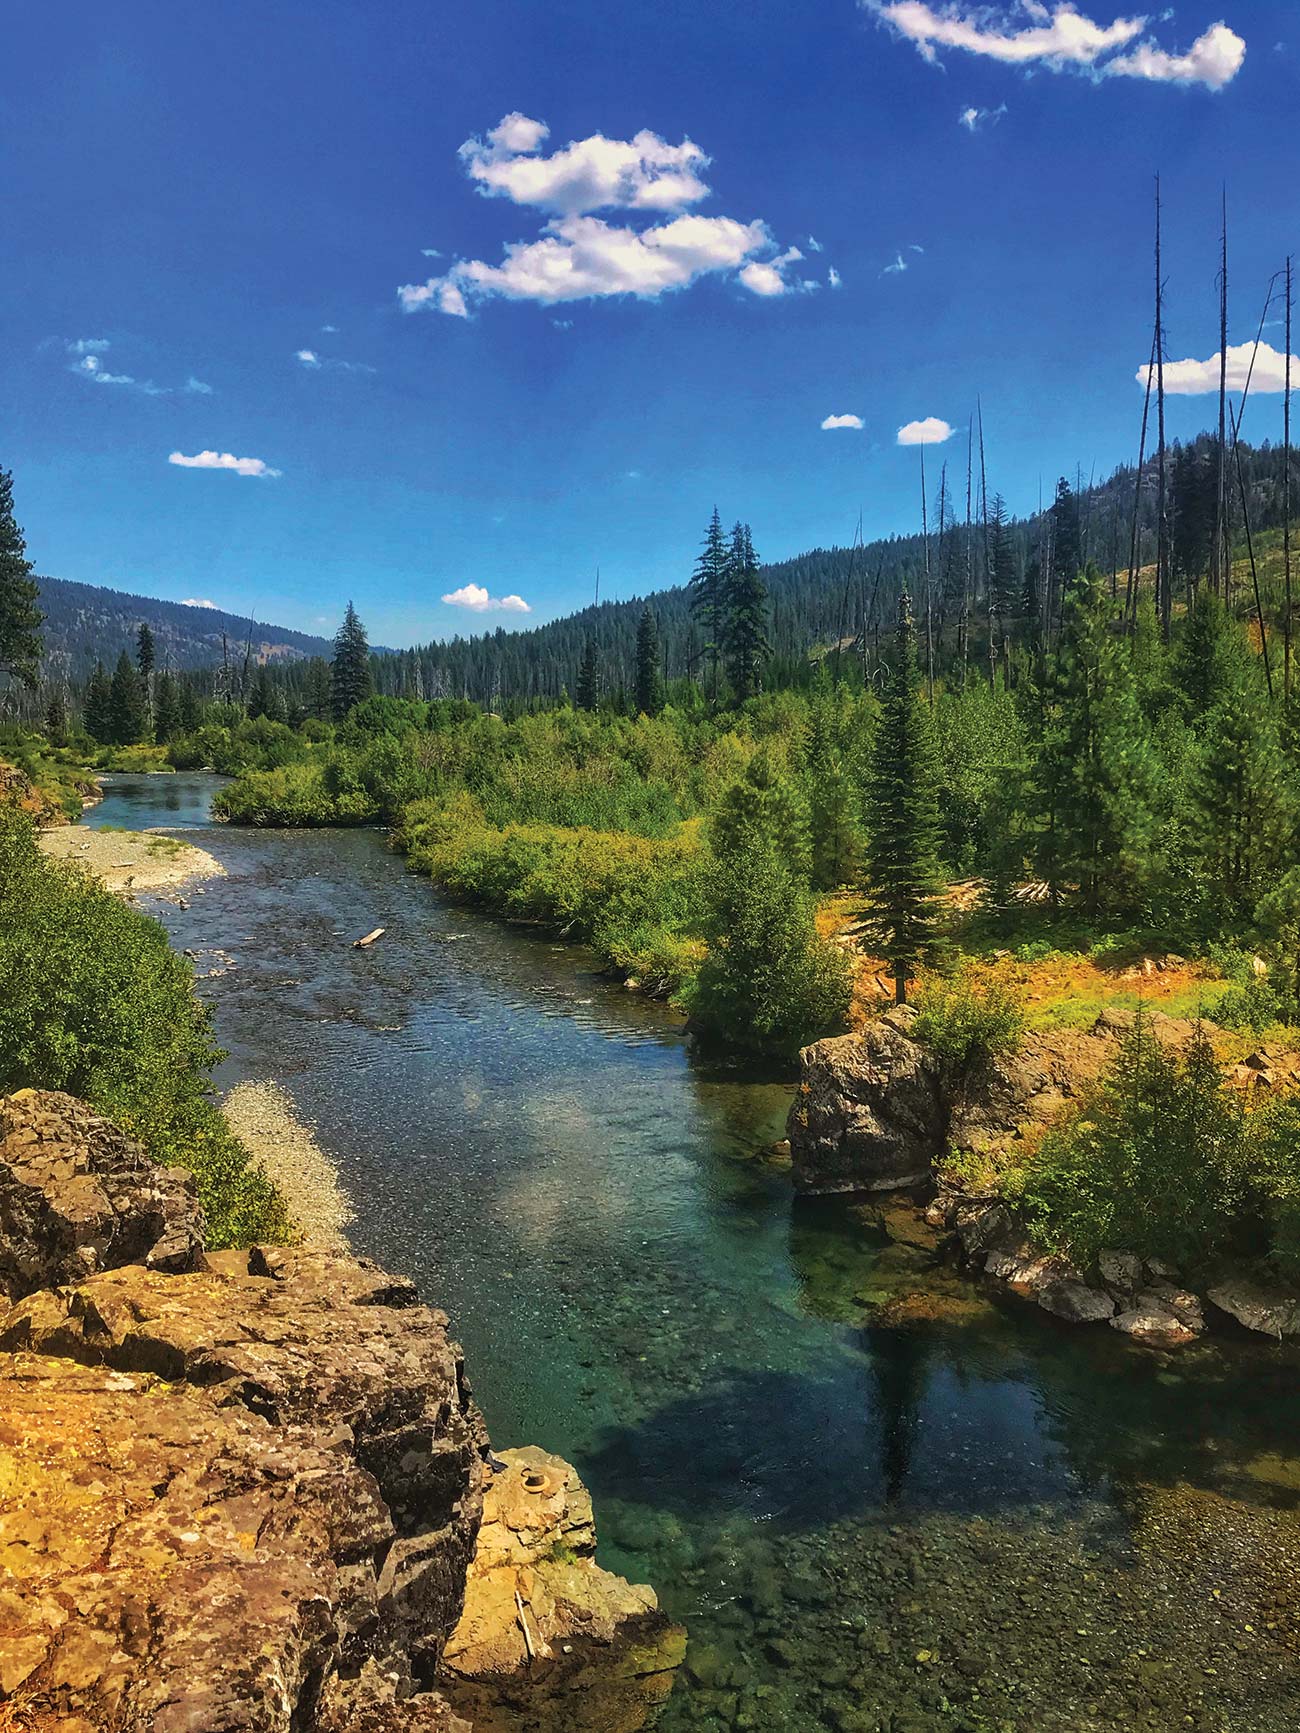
{"left": 789, "top": 1007, "right": 948, "bottom": 1192}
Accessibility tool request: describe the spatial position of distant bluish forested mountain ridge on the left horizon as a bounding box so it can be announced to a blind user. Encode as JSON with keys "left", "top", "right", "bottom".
{"left": 38, "top": 577, "right": 333, "bottom": 681}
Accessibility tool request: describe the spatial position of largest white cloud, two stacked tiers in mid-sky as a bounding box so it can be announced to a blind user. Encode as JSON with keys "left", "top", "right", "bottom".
{"left": 397, "top": 114, "right": 816, "bottom": 319}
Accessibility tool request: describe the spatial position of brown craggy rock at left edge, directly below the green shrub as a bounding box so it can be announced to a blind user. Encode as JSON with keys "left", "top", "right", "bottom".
{"left": 0, "top": 1088, "right": 203, "bottom": 1300}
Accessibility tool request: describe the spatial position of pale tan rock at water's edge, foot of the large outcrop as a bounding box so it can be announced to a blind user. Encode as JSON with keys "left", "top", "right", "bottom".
{"left": 442, "top": 1447, "right": 686, "bottom": 1733}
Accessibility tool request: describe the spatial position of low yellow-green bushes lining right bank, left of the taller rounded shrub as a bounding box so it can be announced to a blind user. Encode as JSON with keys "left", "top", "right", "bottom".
{"left": 395, "top": 792, "right": 700, "bottom": 991}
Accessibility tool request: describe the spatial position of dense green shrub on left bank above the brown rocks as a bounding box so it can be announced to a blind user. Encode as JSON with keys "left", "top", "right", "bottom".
{"left": 0, "top": 811, "right": 289, "bottom": 1246}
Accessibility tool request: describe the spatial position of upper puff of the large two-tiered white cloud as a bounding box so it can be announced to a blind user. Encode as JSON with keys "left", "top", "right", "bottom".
{"left": 459, "top": 114, "right": 709, "bottom": 217}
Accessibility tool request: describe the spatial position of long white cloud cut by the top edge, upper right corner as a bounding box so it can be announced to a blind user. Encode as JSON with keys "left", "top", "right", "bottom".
{"left": 861, "top": 0, "right": 1246, "bottom": 90}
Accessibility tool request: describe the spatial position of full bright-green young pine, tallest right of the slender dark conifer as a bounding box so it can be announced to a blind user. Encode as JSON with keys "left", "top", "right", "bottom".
{"left": 1037, "top": 567, "right": 1156, "bottom": 913}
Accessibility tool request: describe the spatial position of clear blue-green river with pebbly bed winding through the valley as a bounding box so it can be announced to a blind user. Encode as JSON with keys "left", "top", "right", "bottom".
{"left": 90, "top": 776, "right": 1300, "bottom": 1733}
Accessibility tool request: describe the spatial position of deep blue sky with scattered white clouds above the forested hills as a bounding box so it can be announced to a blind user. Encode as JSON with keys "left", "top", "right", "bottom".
{"left": 0, "top": 0, "right": 1300, "bottom": 643}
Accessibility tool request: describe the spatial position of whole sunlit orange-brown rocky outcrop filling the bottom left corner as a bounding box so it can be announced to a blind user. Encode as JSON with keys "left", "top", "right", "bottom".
{"left": 0, "top": 1094, "right": 674, "bottom": 1733}
